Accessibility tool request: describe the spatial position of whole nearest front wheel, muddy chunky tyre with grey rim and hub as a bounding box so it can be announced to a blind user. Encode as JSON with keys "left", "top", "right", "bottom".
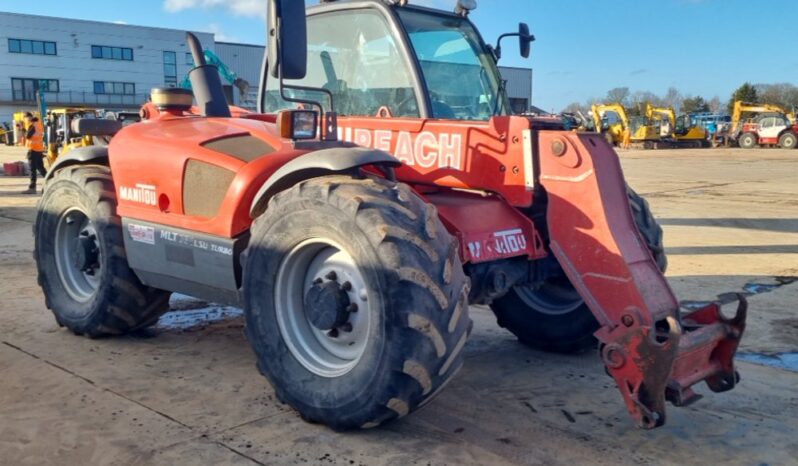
{"left": 243, "top": 176, "right": 471, "bottom": 430}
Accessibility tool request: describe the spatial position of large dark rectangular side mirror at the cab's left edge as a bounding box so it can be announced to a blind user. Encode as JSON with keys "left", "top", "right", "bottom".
{"left": 267, "top": 0, "right": 308, "bottom": 79}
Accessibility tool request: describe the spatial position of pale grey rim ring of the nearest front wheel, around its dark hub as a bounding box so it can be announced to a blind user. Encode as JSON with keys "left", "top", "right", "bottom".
{"left": 275, "top": 239, "right": 372, "bottom": 378}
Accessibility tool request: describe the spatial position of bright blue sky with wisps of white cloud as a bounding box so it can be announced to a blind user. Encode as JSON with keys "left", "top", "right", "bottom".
{"left": 0, "top": 0, "right": 798, "bottom": 111}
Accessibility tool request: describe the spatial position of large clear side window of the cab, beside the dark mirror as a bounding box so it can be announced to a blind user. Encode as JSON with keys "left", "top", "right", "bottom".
{"left": 263, "top": 10, "right": 419, "bottom": 117}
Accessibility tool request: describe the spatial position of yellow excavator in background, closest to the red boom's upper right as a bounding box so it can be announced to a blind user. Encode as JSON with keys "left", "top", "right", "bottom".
{"left": 592, "top": 103, "right": 663, "bottom": 149}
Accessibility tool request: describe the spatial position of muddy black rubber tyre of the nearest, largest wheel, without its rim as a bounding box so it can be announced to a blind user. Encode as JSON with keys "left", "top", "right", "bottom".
{"left": 242, "top": 176, "right": 472, "bottom": 430}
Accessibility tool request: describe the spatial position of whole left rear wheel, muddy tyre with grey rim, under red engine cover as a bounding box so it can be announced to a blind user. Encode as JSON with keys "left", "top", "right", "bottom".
{"left": 33, "top": 165, "right": 170, "bottom": 338}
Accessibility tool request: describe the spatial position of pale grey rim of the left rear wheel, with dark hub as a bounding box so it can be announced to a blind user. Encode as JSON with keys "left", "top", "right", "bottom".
{"left": 55, "top": 209, "right": 102, "bottom": 303}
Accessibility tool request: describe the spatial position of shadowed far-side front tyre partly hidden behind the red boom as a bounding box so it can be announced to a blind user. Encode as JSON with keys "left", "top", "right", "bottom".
{"left": 491, "top": 187, "right": 668, "bottom": 353}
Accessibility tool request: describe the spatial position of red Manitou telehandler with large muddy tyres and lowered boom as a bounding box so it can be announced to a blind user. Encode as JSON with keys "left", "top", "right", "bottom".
{"left": 35, "top": 0, "right": 746, "bottom": 429}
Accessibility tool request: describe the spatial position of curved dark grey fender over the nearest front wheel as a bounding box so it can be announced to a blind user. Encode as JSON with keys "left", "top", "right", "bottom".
{"left": 249, "top": 147, "right": 402, "bottom": 218}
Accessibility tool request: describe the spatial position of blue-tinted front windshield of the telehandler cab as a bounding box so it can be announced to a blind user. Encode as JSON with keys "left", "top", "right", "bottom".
{"left": 398, "top": 8, "right": 507, "bottom": 120}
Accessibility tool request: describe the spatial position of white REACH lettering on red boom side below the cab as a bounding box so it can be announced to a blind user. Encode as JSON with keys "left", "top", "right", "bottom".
{"left": 338, "top": 128, "right": 463, "bottom": 171}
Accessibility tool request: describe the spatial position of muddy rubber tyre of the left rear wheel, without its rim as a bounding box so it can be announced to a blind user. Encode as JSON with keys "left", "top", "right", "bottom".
{"left": 33, "top": 165, "right": 170, "bottom": 338}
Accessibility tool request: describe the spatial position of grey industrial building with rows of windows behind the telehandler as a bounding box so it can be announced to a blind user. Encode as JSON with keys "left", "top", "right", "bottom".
{"left": 0, "top": 12, "right": 532, "bottom": 122}
